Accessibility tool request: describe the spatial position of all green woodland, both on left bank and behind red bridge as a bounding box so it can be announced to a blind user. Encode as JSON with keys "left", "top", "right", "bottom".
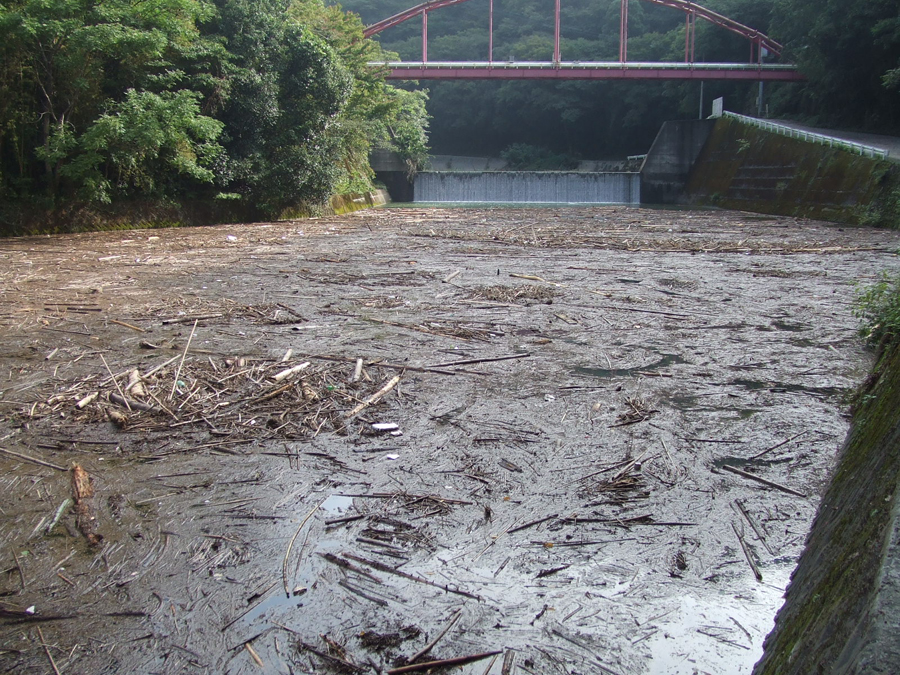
{"left": 0, "top": 0, "right": 900, "bottom": 217}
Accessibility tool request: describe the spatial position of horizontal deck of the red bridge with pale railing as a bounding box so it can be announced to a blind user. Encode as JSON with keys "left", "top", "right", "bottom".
{"left": 370, "top": 61, "right": 804, "bottom": 82}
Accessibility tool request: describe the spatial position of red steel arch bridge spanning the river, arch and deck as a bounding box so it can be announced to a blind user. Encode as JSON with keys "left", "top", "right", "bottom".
{"left": 364, "top": 0, "right": 804, "bottom": 82}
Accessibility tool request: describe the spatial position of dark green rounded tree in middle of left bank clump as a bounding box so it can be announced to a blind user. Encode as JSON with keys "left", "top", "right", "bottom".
{"left": 215, "top": 0, "right": 352, "bottom": 215}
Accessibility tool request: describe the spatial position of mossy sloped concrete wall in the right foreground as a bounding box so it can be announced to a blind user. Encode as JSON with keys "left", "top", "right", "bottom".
{"left": 754, "top": 345, "right": 900, "bottom": 675}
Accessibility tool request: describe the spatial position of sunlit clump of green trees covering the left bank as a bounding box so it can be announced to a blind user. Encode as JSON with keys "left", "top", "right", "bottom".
{"left": 0, "top": 0, "right": 427, "bottom": 216}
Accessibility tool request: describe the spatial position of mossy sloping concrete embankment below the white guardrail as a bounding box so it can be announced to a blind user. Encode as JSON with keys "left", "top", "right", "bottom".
{"left": 687, "top": 118, "right": 900, "bottom": 223}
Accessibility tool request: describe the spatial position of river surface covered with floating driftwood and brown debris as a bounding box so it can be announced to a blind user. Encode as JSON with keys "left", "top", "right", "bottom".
{"left": 0, "top": 207, "right": 900, "bottom": 675}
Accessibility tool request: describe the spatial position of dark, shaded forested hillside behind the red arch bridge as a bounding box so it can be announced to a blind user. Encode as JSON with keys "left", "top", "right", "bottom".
{"left": 343, "top": 0, "right": 900, "bottom": 159}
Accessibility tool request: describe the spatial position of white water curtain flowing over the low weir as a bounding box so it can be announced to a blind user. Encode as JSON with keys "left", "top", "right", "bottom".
{"left": 413, "top": 171, "right": 641, "bottom": 204}
